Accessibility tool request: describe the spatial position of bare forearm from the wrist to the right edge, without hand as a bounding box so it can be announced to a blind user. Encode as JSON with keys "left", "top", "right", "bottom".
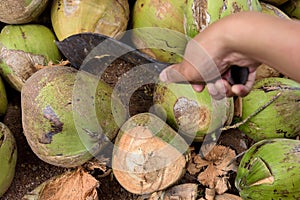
{"left": 216, "top": 12, "right": 300, "bottom": 81}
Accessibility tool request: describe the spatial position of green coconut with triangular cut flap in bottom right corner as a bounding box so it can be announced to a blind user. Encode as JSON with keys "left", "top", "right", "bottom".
{"left": 235, "top": 138, "right": 300, "bottom": 200}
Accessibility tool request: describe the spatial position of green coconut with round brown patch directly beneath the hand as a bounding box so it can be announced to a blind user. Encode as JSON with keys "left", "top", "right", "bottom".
{"left": 153, "top": 83, "right": 234, "bottom": 142}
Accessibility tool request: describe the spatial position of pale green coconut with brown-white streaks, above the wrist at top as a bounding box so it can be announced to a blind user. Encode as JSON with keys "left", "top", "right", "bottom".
{"left": 184, "top": 0, "right": 261, "bottom": 38}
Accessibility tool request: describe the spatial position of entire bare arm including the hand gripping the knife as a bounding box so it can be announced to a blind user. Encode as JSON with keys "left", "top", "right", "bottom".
{"left": 161, "top": 12, "right": 300, "bottom": 97}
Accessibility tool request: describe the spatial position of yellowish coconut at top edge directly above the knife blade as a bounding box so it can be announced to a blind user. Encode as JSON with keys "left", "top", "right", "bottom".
{"left": 51, "top": 0, "right": 129, "bottom": 40}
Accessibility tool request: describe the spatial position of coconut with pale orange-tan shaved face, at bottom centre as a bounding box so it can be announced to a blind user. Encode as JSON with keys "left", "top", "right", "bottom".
{"left": 112, "top": 113, "right": 189, "bottom": 194}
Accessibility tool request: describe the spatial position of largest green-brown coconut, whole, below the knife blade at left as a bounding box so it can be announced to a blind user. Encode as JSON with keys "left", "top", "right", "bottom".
{"left": 21, "top": 67, "right": 125, "bottom": 167}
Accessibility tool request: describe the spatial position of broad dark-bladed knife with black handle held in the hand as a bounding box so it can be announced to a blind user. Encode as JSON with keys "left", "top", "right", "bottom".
{"left": 56, "top": 33, "right": 249, "bottom": 85}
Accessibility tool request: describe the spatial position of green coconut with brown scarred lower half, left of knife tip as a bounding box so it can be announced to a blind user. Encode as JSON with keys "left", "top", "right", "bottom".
{"left": 0, "top": 24, "right": 61, "bottom": 91}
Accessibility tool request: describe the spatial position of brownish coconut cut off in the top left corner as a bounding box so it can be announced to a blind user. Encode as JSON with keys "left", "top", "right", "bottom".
{"left": 0, "top": 0, "right": 49, "bottom": 24}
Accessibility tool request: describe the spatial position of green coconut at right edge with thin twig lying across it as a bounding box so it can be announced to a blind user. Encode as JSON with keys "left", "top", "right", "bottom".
{"left": 239, "top": 77, "right": 300, "bottom": 141}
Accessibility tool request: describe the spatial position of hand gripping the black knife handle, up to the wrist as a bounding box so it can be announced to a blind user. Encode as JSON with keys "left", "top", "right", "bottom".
{"left": 160, "top": 15, "right": 260, "bottom": 99}
